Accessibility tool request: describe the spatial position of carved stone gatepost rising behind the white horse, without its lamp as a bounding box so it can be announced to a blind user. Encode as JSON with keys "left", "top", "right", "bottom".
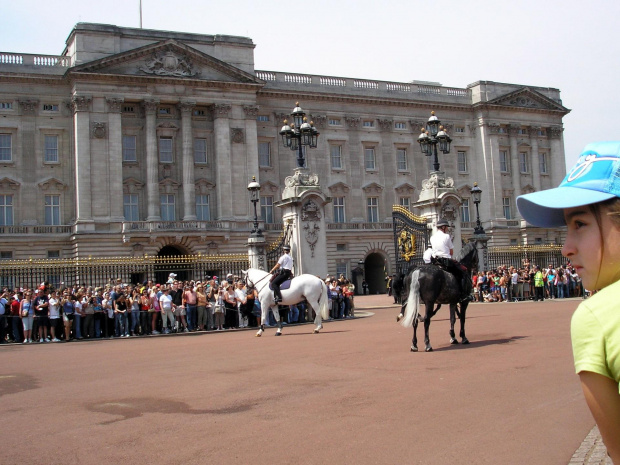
{"left": 274, "top": 168, "right": 331, "bottom": 277}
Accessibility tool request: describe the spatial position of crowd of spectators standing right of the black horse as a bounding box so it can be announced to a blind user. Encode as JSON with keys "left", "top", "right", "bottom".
{"left": 472, "top": 260, "right": 588, "bottom": 302}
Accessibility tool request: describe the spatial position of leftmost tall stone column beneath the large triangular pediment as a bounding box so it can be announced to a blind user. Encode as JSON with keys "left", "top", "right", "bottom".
{"left": 72, "top": 96, "right": 94, "bottom": 231}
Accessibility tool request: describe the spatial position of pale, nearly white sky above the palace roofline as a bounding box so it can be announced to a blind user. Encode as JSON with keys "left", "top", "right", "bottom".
{"left": 0, "top": 0, "right": 620, "bottom": 168}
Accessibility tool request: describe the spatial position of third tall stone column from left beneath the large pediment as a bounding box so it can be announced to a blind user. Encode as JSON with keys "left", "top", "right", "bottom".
{"left": 144, "top": 100, "right": 161, "bottom": 221}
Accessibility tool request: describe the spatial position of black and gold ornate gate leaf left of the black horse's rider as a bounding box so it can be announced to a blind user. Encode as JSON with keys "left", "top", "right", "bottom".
{"left": 392, "top": 205, "right": 428, "bottom": 273}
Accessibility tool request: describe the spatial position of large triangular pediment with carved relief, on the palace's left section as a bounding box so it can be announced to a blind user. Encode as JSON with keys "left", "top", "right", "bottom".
{"left": 68, "top": 39, "right": 263, "bottom": 84}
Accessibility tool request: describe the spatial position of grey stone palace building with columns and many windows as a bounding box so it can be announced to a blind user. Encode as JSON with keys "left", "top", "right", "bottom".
{"left": 0, "top": 23, "right": 569, "bottom": 290}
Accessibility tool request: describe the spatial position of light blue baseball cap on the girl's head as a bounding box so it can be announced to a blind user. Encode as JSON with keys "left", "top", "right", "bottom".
{"left": 517, "top": 141, "right": 620, "bottom": 228}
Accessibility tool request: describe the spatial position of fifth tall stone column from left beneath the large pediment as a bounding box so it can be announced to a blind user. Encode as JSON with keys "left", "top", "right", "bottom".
{"left": 213, "top": 104, "right": 233, "bottom": 220}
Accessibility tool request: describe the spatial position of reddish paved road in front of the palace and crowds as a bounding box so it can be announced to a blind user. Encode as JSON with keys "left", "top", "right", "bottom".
{"left": 0, "top": 296, "right": 594, "bottom": 465}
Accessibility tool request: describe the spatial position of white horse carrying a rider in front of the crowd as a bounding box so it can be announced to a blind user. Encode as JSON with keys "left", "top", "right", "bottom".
{"left": 243, "top": 268, "right": 329, "bottom": 337}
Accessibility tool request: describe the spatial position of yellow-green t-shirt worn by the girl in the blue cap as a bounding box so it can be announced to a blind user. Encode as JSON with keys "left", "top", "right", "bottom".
{"left": 571, "top": 281, "right": 620, "bottom": 392}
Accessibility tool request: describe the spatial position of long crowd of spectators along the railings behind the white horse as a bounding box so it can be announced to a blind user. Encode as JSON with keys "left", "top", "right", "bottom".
{"left": 0, "top": 273, "right": 354, "bottom": 344}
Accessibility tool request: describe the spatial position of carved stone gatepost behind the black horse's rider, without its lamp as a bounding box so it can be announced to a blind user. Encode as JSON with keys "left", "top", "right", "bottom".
{"left": 413, "top": 171, "right": 463, "bottom": 256}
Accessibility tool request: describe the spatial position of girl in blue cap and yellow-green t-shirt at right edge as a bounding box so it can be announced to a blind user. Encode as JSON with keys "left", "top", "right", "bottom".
{"left": 517, "top": 142, "right": 620, "bottom": 458}
